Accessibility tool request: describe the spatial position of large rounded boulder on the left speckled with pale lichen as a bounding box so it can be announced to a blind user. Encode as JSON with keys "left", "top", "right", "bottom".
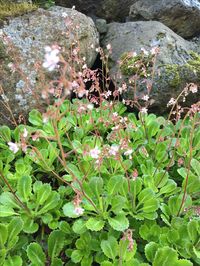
{"left": 0, "top": 6, "right": 99, "bottom": 124}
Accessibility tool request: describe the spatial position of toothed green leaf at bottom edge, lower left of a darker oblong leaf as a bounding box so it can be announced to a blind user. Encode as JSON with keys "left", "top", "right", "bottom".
{"left": 26, "top": 243, "right": 46, "bottom": 266}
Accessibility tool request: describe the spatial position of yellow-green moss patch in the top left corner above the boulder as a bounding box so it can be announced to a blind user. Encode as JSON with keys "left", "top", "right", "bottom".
{"left": 0, "top": 0, "right": 37, "bottom": 20}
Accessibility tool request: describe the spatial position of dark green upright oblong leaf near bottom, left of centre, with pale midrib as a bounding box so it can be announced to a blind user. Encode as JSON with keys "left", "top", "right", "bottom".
{"left": 48, "top": 230, "right": 65, "bottom": 259}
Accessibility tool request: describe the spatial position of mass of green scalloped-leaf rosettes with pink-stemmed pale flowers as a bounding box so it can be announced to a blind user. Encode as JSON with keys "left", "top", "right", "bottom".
{"left": 0, "top": 8, "right": 200, "bottom": 266}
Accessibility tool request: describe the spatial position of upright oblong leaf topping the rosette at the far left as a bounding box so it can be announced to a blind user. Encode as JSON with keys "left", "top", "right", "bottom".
{"left": 17, "top": 176, "right": 32, "bottom": 202}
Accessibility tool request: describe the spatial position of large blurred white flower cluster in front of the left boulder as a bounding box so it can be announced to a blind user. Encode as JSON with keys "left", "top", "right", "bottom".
{"left": 42, "top": 46, "right": 60, "bottom": 71}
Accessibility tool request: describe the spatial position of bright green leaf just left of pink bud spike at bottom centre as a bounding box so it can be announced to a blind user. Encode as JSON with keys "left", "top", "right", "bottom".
{"left": 101, "top": 236, "right": 118, "bottom": 260}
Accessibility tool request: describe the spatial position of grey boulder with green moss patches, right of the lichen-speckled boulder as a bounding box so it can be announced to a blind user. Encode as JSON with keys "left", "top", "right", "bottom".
{"left": 103, "top": 21, "right": 200, "bottom": 113}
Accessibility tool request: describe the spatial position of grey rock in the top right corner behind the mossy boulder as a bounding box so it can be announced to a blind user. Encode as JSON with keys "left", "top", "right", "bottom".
{"left": 129, "top": 0, "right": 200, "bottom": 38}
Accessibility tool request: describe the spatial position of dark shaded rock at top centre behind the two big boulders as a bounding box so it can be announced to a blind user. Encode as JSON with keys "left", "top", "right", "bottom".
{"left": 55, "top": 0, "right": 136, "bottom": 22}
